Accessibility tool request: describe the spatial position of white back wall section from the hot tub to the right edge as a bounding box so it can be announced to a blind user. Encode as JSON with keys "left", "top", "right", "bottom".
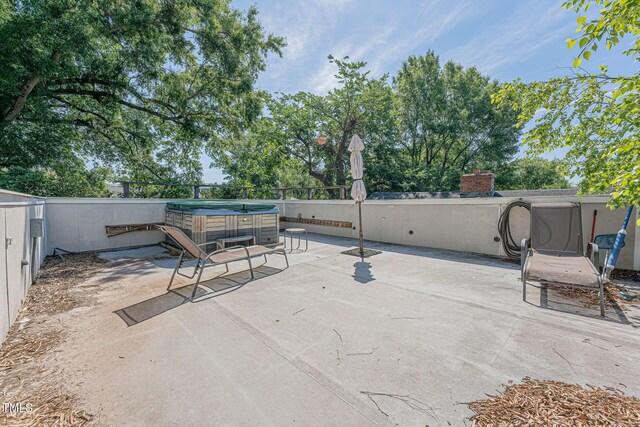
{"left": 283, "top": 196, "right": 640, "bottom": 270}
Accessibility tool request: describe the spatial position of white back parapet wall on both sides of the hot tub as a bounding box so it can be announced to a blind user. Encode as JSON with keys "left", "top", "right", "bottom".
{"left": 42, "top": 196, "right": 640, "bottom": 270}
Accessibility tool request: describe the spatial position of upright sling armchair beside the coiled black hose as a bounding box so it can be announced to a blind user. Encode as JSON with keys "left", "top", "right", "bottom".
{"left": 520, "top": 203, "right": 604, "bottom": 317}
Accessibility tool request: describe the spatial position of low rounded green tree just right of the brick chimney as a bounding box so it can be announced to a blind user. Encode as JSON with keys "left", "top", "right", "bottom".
{"left": 495, "top": 157, "right": 571, "bottom": 190}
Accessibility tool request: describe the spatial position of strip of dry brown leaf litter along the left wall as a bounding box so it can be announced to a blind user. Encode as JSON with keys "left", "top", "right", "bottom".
{"left": 0, "top": 254, "right": 105, "bottom": 426}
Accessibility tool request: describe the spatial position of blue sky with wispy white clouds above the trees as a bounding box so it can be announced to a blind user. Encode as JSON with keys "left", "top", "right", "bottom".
{"left": 203, "top": 0, "right": 637, "bottom": 182}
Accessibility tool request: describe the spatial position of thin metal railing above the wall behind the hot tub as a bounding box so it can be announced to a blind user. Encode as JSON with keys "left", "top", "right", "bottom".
{"left": 114, "top": 181, "right": 347, "bottom": 200}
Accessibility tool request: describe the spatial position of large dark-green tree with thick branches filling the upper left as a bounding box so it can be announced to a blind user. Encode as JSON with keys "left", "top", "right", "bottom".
{"left": 0, "top": 0, "right": 284, "bottom": 197}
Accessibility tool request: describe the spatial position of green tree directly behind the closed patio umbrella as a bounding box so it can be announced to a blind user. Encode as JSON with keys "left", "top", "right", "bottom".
{"left": 208, "top": 56, "right": 394, "bottom": 195}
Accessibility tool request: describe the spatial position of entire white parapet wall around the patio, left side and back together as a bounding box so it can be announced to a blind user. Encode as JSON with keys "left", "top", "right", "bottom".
{"left": 0, "top": 190, "right": 640, "bottom": 346}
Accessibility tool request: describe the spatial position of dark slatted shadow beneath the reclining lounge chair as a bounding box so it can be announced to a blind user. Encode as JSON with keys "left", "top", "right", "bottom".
{"left": 114, "top": 265, "right": 282, "bottom": 326}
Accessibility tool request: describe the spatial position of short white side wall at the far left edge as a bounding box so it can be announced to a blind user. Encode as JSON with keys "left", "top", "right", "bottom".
{"left": 0, "top": 190, "right": 46, "bottom": 342}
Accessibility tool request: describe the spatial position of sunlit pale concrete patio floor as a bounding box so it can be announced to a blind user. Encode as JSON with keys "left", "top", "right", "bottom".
{"left": 53, "top": 235, "right": 640, "bottom": 426}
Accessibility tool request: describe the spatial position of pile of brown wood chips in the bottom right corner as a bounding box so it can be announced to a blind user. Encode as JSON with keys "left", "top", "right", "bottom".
{"left": 468, "top": 378, "right": 640, "bottom": 427}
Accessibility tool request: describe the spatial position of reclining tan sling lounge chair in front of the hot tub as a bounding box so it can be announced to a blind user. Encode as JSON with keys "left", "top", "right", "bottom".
{"left": 158, "top": 225, "right": 289, "bottom": 302}
